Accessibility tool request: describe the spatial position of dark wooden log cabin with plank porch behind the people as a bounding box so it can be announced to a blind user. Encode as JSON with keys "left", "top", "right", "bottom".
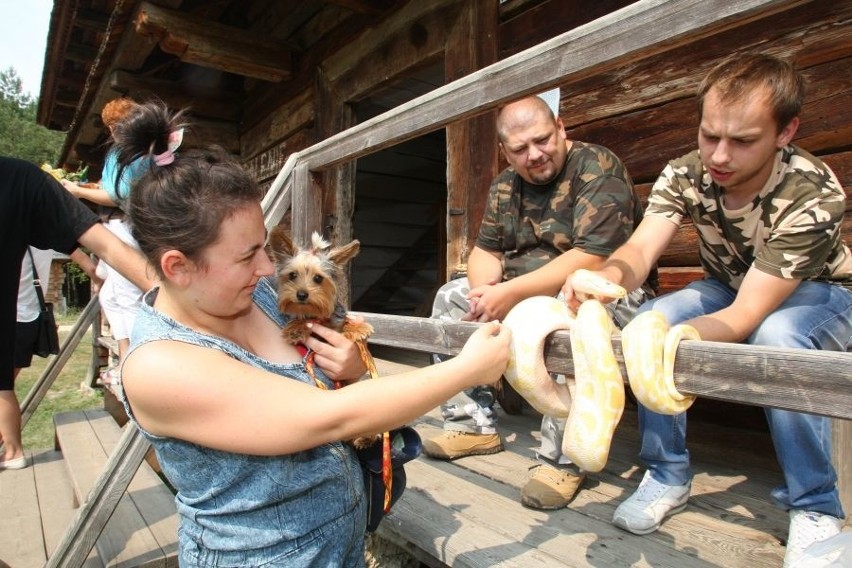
{"left": 23, "top": 0, "right": 852, "bottom": 566}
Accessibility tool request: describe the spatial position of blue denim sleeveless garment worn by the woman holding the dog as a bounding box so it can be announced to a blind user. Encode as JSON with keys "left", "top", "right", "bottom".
{"left": 122, "top": 279, "right": 366, "bottom": 568}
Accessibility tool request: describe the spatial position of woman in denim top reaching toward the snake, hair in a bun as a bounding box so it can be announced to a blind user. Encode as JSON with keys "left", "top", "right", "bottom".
{"left": 115, "top": 100, "right": 509, "bottom": 568}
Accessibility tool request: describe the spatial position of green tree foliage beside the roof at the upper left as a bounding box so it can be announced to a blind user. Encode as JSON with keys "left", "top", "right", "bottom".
{"left": 0, "top": 67, "right": 65, "bottom": 165}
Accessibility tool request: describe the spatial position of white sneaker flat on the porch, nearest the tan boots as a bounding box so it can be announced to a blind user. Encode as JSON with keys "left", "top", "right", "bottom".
{"left": 612, "top": 470, "right": 692, "bottom": 534}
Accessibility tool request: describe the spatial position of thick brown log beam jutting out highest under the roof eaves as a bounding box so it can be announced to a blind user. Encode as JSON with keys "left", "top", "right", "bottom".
{"left": 135, "top": 2, "right": 291, "bottom": 82}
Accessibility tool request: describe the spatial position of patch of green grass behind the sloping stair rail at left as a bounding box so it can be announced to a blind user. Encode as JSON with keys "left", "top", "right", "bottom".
{"left": 15, "top": 308, "right": 103, "bottom": 450}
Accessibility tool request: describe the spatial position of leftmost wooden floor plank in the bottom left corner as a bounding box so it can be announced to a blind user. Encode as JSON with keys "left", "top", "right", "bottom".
{"left": 0, "top": 452, "right": 46, "bottom": 568}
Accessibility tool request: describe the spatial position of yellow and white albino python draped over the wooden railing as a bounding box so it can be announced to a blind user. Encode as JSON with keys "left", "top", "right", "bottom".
{"left": 503, "top": 270, "right": 700, "bottom": 472}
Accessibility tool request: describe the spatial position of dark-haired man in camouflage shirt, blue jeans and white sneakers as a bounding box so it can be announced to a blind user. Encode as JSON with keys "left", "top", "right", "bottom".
{"left": 564, "top": 54, "right": 852, "bottom": 566}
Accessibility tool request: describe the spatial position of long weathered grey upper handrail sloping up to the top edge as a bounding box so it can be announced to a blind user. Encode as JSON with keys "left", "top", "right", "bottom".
{"left": 290, "top": 0, "right": 802, "bottom": 173}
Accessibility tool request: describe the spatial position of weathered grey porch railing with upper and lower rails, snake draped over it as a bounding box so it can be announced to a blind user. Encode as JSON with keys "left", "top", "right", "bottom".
{"left": 263, "top": 0, "right": 852, "bottom": 419}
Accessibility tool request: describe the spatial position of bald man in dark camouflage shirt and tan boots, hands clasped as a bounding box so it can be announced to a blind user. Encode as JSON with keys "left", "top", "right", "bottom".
{"left": 423, "top": 96, "right": 651, "bottom": 509}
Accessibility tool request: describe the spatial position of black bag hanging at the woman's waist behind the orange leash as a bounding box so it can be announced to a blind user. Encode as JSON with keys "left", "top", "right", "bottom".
{"left": 357, "top": 426, "right": 423, "bottom": 532}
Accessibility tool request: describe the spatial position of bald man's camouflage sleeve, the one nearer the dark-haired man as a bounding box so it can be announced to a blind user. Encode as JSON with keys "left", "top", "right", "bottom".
{"left": 572, "top": 175, "right": 637, "bottom": 256}
